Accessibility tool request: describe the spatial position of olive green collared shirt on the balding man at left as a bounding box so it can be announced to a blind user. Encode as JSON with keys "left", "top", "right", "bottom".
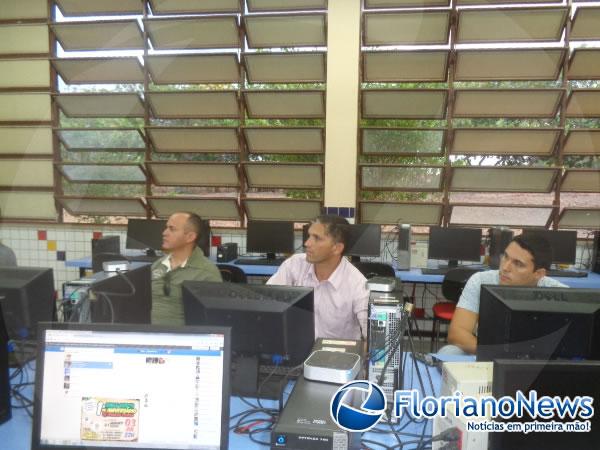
{"left": 152, "top": 247, "right": 222, "bottom": 326}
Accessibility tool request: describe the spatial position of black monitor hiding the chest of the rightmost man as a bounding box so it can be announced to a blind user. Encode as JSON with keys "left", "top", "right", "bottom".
{"left": 477, "top": 285, "right": 600, "bottom": 361}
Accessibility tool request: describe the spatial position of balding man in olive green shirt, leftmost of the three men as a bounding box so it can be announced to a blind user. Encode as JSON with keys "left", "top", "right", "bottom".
{"left": 152, "top": 212, "right": 223, "bottom": 326}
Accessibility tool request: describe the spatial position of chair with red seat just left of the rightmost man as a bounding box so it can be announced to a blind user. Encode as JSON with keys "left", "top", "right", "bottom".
{"left": 431, "top": 267, "right": 479, "bottom": 353}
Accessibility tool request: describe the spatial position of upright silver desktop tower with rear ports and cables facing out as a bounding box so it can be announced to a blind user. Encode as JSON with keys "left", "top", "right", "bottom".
{"left": 368, "top": 292, "right": 402, "bottom": 405}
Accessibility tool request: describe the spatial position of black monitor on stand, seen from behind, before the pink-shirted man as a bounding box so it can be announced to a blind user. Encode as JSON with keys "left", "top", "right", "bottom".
{"left": 182, "top": 281, "right": 315, "bottom": 395}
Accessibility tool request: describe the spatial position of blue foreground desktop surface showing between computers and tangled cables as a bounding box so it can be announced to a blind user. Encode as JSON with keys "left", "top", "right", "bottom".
{"left": 0, "top": 354, "right": 441, "bottom": 450}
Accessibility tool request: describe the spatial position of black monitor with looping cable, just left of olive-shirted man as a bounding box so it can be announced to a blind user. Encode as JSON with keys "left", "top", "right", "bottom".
{"left": 90, "top": 262, "right": 152, "bottom": 324}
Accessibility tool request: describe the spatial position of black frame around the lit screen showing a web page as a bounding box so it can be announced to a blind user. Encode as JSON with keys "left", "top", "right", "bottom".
{"left": 31, "top": 322, "right": 231, "bottom": 450}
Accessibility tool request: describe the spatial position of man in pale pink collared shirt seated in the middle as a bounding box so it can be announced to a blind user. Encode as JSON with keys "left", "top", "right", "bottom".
{"left": 267, "top": 215, "right": 369, "bottom": 339}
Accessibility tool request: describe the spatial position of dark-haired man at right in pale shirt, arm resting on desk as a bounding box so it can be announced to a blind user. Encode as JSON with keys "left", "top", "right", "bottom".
{"left": 446, "top": 235, "right": 567, "bottom": 354}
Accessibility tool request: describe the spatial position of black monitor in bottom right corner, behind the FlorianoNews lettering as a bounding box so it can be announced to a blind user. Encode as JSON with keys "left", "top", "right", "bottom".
{"left": 488, "top": 360, "right": 600, "bottom": 450}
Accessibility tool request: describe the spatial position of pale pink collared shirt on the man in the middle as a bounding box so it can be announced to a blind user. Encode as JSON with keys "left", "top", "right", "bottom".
{"left": 267, "top": 253, "right": 369, "bottom": 339}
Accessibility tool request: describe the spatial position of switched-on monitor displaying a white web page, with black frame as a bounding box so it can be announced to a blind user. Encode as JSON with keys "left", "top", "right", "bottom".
{"left": 31, "top": 323, "right": 231, "bottom": 450}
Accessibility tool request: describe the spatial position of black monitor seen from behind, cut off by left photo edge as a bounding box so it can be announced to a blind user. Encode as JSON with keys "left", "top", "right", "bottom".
{"left": 0, "top": 267, "right": 56, "bottom": 339}
